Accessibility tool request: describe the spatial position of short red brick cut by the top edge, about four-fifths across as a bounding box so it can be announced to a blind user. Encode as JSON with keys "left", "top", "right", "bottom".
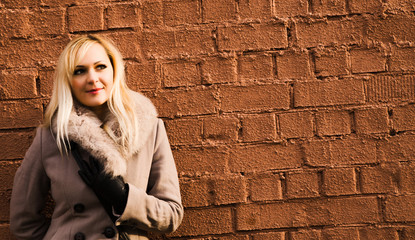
{"left": 312, "top": 0, "right": 347, "bottom": 16}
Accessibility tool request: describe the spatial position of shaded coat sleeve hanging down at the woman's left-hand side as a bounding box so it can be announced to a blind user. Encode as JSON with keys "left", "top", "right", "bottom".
{"left": 10, "top": 127, "right": 50, "bottom": 239}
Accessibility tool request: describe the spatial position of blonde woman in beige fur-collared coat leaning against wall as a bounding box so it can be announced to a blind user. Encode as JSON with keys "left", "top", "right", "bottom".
{"left": 10, "top": 35, "right": 183, "bottom": 240}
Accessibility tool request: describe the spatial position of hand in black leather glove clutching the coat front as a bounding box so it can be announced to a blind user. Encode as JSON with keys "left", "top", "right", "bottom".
{"left": 78, "top": 156, "right": 128, "bottom": 214}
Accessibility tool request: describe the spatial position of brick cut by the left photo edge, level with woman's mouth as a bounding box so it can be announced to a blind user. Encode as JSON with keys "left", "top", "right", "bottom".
{"left": 0, "top": 69, "right": 37, "bottom": 99}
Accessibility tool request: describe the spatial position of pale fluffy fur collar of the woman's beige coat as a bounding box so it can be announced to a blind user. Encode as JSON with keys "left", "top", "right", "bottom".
{"left": 52, "top": 91, "right": 157, "bottom": 177}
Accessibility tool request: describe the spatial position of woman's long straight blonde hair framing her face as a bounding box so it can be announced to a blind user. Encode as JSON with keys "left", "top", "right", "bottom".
{"left": 44, "top": 35, "right": 139, "bottom": 154}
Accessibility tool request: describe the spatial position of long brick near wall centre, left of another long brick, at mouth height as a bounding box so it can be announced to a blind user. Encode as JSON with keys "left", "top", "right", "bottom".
{"left": 220, "top": 84, "right": 290, "bottom": 112}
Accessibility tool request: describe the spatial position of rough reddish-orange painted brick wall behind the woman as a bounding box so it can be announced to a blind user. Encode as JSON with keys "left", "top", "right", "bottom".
{"left": 0, "top": 0, "right": 415, "bottom": 240}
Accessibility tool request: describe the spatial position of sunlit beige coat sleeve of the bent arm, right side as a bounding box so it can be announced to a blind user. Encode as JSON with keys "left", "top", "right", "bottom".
{"left": 118, "top": 120, "right": 183, "bottom": 233}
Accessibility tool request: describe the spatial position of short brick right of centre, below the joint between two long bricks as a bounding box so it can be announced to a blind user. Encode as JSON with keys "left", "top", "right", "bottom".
{"left": 278, "top": 112, "right": 314, "bottom": 138}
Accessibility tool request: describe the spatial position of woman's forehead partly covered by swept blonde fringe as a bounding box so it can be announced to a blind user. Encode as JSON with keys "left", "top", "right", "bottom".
{"left": 76, "top": 43, "right": 109, "bottom": 65}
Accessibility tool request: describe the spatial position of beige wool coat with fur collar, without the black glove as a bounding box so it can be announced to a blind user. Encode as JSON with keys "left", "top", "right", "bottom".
{"left": 10, "top": 92, "right": 183, "bottom": 240}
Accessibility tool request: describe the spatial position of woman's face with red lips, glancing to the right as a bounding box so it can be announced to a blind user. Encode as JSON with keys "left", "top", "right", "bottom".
{"left": 71, "top": 43, "right": 114, "bottom": 109}
